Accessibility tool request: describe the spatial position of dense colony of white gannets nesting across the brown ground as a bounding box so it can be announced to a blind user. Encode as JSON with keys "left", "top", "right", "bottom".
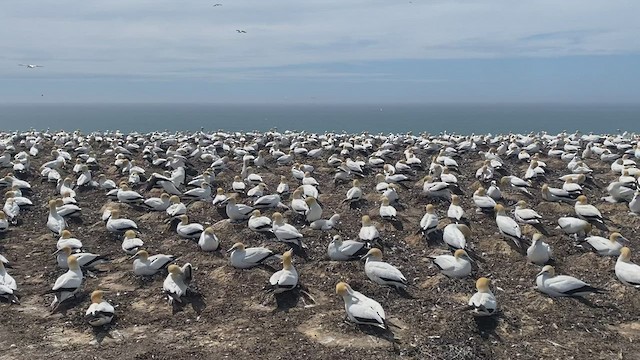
{"left": 0, "top": 131, "right": 640, "bottom": 358}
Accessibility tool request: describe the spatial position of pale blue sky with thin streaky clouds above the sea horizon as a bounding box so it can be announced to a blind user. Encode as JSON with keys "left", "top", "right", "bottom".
{"left": 0, "top": 0, "right": 640, "bottom": 104}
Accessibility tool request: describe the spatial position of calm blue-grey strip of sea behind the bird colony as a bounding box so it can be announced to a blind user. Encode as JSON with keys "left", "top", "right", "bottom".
{"left": 0, "top": 104, "right": 640, "bottom": 134}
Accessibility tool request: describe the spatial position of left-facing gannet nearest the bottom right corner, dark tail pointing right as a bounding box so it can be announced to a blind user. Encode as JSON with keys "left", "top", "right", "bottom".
{"left": 536, "top": 265, "right": 603, "bottom": 297}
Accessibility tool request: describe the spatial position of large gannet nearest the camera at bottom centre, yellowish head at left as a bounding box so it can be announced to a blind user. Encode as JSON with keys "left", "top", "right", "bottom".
{"left": 336, "top": 282, "right": 387, "bottom": 329}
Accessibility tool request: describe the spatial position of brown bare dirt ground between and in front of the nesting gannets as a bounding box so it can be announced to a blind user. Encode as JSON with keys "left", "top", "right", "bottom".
{"left": 0, "top": 134, "right": 640, "bottom": 360}
